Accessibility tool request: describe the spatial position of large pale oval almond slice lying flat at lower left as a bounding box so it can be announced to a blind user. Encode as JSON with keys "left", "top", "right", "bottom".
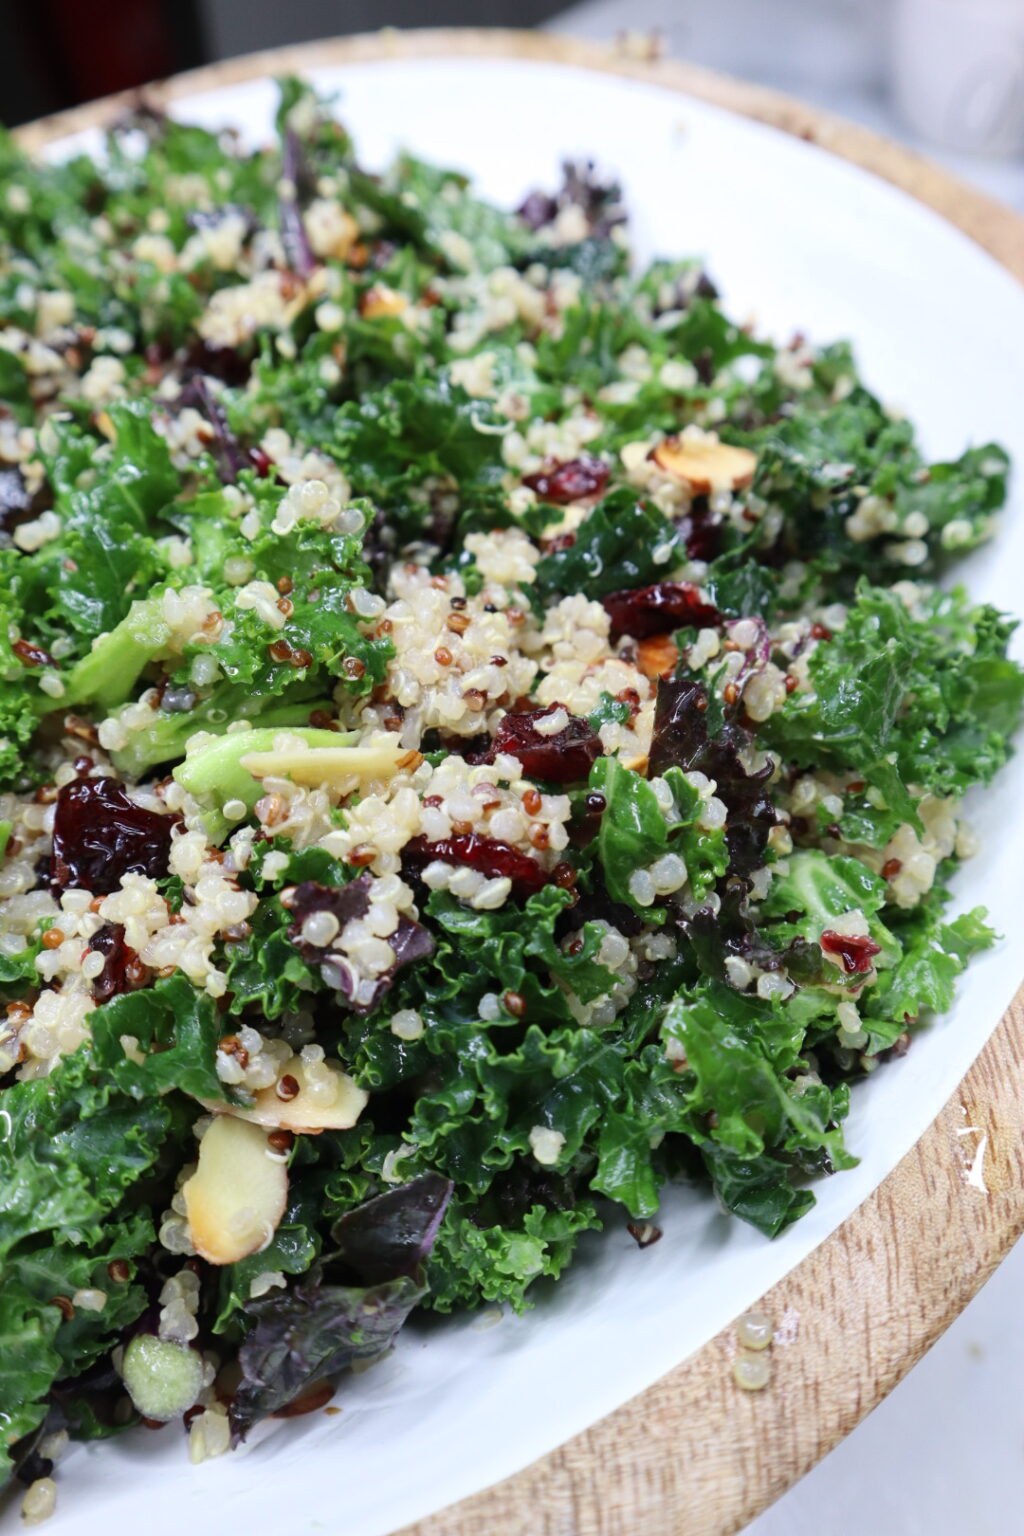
{"left": 181, "top": 1115, "right": 289, "bottom": 1264}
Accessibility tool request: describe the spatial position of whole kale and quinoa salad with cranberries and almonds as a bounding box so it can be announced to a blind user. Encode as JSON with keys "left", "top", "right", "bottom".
{"left": 0, "top": 80, "right": 1024, "bottom": 1519}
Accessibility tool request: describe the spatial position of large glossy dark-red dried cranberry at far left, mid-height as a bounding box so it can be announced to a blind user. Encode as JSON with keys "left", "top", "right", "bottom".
{"left": 49, "top": 779, "right": 177, "bottom": 895}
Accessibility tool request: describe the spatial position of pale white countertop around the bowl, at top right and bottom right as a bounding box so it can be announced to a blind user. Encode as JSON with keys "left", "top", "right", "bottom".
{"left": 550, "top": 0, "right": 1024, "bottom": 1536}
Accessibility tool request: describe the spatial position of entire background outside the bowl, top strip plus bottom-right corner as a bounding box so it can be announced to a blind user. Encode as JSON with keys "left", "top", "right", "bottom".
{"left": 0, "top": 0, "right": 1024, "bottom": 1536}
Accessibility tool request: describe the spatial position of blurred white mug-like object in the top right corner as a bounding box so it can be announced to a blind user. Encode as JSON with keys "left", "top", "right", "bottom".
{"left": 892, "top": 0, "right": 1024, "bottom": 155}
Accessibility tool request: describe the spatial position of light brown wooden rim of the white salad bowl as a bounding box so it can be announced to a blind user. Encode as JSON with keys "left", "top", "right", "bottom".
{"left": 18, "top": 29, "right": 1024, "bottom": 1536}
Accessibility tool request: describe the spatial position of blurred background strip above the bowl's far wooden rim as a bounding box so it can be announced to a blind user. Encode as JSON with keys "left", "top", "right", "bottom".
{"left": 0, "top": 0, "right": 1024, "bottom": 209}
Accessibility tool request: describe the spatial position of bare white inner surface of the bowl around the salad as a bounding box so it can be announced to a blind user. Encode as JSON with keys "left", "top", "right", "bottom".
{"left": 33, "top": 48, "right": 1024, "bottom": 1536}
